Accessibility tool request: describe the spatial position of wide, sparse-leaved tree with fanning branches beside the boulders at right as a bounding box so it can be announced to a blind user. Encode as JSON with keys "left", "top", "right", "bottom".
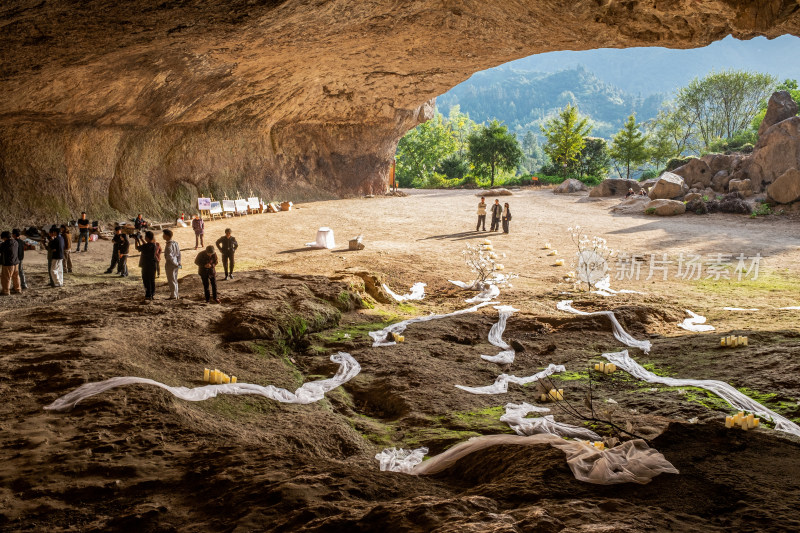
{"left": 676, "top": 70, "right": 777, "bottom": 150}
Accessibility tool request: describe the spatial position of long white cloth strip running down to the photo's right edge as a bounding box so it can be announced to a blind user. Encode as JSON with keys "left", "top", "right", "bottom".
{"left": 603, "top": 350, "right": 800, "bottom": 437}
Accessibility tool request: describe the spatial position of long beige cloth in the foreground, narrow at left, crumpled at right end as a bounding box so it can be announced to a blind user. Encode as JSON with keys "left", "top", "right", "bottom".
{"left": 412, "top": 434, "right": 678, "bottom": 485}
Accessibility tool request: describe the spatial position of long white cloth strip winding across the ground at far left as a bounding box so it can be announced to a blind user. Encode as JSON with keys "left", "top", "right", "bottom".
{"left": 45, "top": 352, "right": 361, "bottom": 411}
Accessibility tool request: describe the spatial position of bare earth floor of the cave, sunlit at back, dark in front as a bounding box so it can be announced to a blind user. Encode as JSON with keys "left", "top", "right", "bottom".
{"left": 0, "top": 190, "right": 800, "bottom": 532}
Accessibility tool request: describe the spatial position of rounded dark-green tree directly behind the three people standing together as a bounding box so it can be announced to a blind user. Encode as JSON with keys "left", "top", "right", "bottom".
{"left": 467, "top": 120, "right": 523, "bottom": 186}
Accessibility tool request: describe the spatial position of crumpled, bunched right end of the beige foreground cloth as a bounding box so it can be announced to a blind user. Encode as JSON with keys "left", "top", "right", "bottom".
{"left": 551, "top": 439, "right": 680, "bottom": 485}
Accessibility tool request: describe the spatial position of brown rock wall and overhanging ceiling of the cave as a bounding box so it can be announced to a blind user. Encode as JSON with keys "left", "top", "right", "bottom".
{"left": 0, "top": 0, "right": 800, "bottom": 222}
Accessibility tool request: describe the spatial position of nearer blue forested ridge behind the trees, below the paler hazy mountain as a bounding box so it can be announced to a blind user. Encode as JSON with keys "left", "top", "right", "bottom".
{"left": 436, "top": 66, "right": 664, "bottom": 138}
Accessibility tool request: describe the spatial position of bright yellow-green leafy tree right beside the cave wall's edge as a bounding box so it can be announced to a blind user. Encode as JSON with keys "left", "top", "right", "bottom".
{"left": 395, "top": 113, "right": 457, "bottom": 187}
